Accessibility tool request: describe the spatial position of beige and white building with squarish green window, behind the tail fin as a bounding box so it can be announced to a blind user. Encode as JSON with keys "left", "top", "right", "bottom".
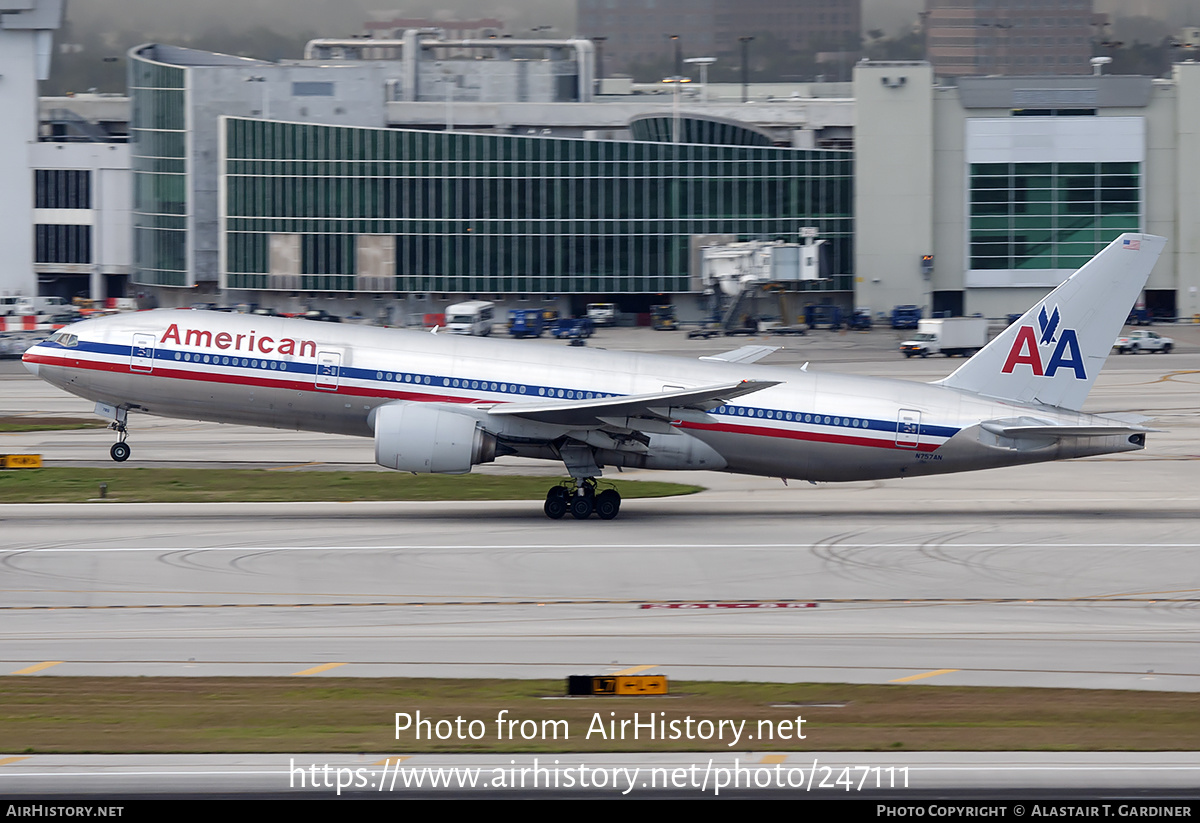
{"left": 854, "top": 62, "right": 1200, "bottom": 318}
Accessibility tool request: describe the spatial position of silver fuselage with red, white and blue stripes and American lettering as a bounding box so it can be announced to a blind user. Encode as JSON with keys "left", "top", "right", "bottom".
{"left": 25, "top": 310, "right": 1141, "bottom": 481}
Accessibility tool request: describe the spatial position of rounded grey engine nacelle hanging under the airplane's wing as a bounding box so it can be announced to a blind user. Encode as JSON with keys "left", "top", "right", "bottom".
{"left": 374, "top": 403, "right": 496, "bottom": 474}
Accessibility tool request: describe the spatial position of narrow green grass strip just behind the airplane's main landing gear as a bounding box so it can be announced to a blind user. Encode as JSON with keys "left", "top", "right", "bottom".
{"left": 0, "top": 465, "right": 701, "bottom": 503}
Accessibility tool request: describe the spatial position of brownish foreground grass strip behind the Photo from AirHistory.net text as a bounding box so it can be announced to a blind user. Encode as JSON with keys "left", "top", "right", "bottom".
{"left": 0, "top": 681, "right": 1200, "bottom": 753}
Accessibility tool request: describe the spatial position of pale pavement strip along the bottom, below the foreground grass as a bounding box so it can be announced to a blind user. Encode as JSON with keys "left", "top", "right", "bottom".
{"left": 0, "top": 751, "right": 1200, "bottom": 801}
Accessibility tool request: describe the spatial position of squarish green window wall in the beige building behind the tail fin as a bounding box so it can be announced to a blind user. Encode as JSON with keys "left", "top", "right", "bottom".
{"left": 970, "top": 163, "right": 1142, "bottom": 270}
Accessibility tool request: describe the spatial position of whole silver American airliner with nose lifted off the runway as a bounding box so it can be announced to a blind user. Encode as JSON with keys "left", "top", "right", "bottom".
{"left": 24, "top": 234, "right": 1166, "bottom": 519}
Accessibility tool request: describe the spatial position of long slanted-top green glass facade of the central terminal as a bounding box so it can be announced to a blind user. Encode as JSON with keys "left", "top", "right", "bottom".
{"left": 222, "top": 118, "right": 853, "bottom": 294}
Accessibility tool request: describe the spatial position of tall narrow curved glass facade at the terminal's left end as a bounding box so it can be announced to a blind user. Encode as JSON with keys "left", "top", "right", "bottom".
{"left": 130, "top": 54, "right": 192, "bottom": 286}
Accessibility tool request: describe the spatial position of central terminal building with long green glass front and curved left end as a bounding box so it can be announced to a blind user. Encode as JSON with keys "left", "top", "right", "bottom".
{"left": 130, "top": 37, "right": 853, "bottom": 322}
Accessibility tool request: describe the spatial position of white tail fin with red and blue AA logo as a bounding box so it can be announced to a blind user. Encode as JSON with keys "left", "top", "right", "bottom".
{"left": 941, "top": 234, "right": 1166, "bottom": 410}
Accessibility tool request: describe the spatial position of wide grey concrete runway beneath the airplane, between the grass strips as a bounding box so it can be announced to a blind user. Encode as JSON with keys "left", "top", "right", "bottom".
{"left": 0, "top": 338, "right": 1200, "bottom": 691}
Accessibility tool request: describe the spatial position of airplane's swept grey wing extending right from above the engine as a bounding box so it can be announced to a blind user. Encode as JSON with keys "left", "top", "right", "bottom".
{"left": 488, "top": 380, "right": 780, "bottom": 426}
